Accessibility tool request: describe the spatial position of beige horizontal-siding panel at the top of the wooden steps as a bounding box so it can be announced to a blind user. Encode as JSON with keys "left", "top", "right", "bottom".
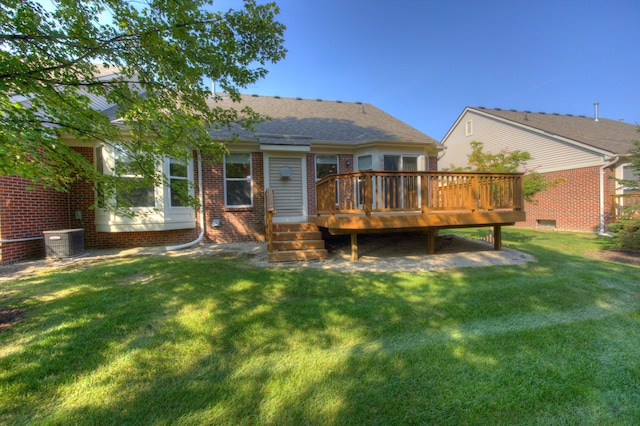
{"left": 269, "top": 157, "right": 304, "bottom": 218}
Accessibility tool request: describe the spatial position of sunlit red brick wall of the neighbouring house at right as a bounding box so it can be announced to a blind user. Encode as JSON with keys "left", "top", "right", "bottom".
{"left": 516, "top": 166, "right": 615, "bottom": 232}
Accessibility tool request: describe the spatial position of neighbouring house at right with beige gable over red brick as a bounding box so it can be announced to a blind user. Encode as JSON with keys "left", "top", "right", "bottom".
{"left": 439, "top": 107, "right": 640, "bottom": 232}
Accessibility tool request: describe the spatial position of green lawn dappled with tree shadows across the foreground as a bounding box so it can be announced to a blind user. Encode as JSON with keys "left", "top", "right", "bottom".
{"left": 0, "top": 229, "right": 640, "bottom": 425}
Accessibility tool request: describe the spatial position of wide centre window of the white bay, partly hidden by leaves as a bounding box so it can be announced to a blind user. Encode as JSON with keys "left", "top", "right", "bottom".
{"left": 114, "top": 150, "right": 156, "bottom": 207}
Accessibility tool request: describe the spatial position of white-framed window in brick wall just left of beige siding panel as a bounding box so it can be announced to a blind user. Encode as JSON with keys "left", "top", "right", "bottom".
{"left": 224, "top": 153, "right": 253, "bottom": 207}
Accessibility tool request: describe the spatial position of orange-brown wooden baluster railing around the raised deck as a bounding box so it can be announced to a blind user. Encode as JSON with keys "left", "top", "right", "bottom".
{"left": 316, "top": 171, "right": 524, "bottom": 215}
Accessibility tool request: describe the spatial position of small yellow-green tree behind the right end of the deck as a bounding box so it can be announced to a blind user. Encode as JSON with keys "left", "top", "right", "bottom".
{"left": 454, "top": 141, "right": 564, "bottom": 203}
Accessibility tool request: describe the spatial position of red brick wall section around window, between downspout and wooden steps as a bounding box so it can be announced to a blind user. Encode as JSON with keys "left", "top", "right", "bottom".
{"left": 202, "top": 152, "right": 265, "bottom": 243}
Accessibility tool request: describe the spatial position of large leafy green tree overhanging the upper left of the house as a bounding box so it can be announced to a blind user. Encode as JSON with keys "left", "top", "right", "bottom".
{"left": 0, "top": 0, "right": 286, "bottom": 213}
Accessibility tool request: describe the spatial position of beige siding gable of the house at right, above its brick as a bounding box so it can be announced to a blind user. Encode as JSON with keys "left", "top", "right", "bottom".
{"left": 439, "top": 111, "right": 603, "bottom": 172}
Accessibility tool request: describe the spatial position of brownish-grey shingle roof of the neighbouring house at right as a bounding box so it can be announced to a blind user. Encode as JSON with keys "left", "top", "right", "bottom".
{"left": 470, "top": 107, "right": 640, "bottom": 155}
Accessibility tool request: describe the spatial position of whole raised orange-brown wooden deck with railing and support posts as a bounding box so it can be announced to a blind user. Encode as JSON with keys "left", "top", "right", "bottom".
{"left": 309, "top": 171, "right": 525, "bottom": 259}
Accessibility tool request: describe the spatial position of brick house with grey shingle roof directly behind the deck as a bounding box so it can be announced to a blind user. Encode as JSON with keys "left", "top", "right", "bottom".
{"left": 0, "top": 82, "right": 442, "bottom": 263}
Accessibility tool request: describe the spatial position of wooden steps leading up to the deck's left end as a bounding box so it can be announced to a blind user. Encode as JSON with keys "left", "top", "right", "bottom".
{"left": 268, "top": 223, "right": 328, "bottom": 262}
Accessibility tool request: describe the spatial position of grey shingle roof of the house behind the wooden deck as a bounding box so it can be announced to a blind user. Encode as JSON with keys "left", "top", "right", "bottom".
{"left": 211, "top": 95, "right": 440, "bottom": 145}
